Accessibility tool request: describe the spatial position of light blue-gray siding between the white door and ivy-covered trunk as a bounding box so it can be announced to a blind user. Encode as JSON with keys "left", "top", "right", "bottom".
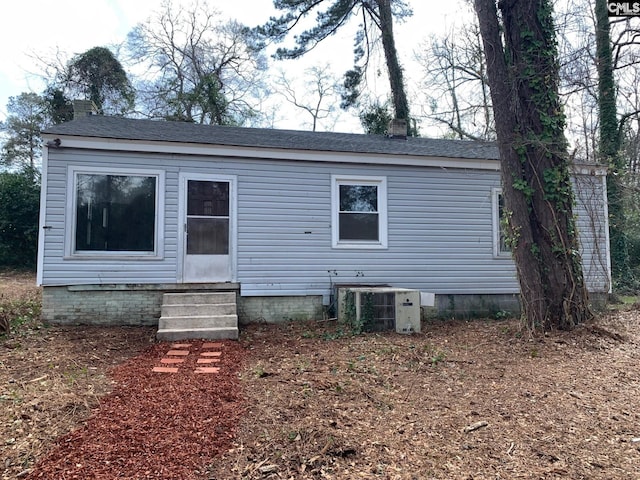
{"left": 238, "top": 163, "right": 517, "bottom": 295}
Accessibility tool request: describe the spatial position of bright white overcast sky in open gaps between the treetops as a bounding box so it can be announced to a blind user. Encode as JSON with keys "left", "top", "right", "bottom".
{"left": 0, "top": 0, "right": 470, "bottom": 131}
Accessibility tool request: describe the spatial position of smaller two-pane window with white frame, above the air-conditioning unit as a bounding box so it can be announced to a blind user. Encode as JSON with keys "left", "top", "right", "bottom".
{"left": 331, "top": 175, "right": 387, "bottom": 248}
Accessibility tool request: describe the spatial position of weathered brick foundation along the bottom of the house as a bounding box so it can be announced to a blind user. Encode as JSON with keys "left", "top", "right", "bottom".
{"left": 42, "top": 283, "right": 572, "bottom": 326}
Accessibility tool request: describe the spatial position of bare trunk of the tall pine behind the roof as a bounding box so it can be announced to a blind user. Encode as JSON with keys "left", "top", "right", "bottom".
{"left": 376, "top": 0, "right": 415, "bottom": 129}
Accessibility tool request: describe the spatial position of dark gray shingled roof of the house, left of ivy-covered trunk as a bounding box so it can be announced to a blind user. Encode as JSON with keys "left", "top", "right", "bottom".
{"left": 43, "top": 115, "right": 499, "bottom": 160}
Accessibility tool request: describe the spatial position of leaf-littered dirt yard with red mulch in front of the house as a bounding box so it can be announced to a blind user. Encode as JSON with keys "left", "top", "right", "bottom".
{"left": 0, "top": 272, "right": 640, "bottom": 480}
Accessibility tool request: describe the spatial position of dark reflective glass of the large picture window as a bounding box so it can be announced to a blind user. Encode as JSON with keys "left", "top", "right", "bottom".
{"left": 76, "top": 174, "right": 156, "bottom": 252}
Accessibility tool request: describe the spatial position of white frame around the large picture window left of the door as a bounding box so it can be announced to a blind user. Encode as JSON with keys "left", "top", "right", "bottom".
{"left": 65, "top": 166, "right": 165, "bottom": 260}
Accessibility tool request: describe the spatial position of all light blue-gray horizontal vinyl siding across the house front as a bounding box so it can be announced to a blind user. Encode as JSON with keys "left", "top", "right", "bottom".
{"left": 42, "top": 149, "right": 608, "bottom": 296}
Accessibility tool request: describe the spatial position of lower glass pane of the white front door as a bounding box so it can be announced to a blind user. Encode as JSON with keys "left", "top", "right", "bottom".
{"left": 187, "top": 218, "right": 229, "bottom": 255}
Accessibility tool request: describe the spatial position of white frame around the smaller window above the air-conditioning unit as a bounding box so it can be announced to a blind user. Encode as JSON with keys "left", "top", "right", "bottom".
{"left": 331, "top": 175, "right": 388, "bottom": 249}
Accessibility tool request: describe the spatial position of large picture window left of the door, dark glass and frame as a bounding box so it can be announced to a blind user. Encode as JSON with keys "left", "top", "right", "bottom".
{"left": 69, "top": 169, "right": 163, "bottom": 257}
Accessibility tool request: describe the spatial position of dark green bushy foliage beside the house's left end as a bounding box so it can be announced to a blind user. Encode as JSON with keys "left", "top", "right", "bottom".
{"left": 0, "top": 166, "right": 40, "bottom": 269}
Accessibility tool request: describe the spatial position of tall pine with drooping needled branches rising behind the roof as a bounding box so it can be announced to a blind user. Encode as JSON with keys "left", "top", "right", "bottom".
{"left": 255, "top": 0, "right": 416, "bottom": 134}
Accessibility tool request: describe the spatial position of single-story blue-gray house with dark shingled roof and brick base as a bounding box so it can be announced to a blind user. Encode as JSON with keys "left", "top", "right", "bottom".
{"left": 38, "top": 115, "right": 611, "bottom": 325}
